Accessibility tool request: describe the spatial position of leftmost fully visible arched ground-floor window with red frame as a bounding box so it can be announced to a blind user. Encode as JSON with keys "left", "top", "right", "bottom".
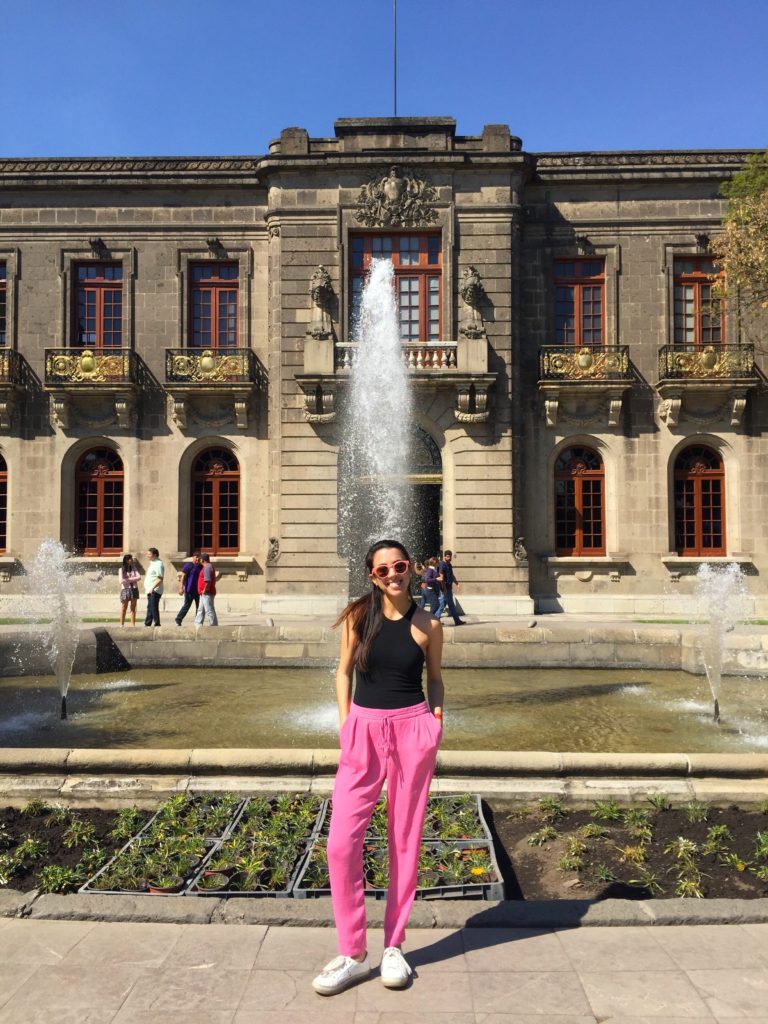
{"left": 75, "top": 449, "right": 123, "bottom": 555}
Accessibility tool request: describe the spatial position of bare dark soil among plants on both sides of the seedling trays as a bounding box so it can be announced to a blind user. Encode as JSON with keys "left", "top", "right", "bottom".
{"left": 0, "top": 800, "right": 768, "bottom": 900}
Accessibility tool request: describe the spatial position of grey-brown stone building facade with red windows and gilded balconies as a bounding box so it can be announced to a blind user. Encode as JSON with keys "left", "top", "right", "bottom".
{"left": 0, "top": 118, "right": 768, "bottom": 614}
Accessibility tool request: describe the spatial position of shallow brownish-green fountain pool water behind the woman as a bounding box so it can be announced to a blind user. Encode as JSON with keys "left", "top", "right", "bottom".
{"left": 0, "top": 668, "right": 768, "bottom": 753}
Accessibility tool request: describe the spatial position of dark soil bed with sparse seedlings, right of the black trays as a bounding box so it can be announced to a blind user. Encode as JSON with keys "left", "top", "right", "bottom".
{"left": 492, "top": 794, "right": 768, "bottom": 900}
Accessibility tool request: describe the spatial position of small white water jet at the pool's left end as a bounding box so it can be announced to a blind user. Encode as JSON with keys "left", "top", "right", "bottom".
{"left": 24, "top": 539, "right": 80, "bottom": 718}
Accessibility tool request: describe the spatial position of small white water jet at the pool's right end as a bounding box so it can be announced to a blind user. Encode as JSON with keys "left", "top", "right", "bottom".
{"left": 693, "top": 562, "right": 749, "bottom": 724}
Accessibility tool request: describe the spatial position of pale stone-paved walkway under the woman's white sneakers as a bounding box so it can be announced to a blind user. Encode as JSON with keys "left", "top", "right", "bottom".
{"left": 0, "top": 919, "right": 768, "bottom": 1024}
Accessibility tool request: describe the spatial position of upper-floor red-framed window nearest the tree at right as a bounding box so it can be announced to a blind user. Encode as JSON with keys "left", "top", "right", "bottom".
{"left": 673, "top": 256, "right": 725, "bottom": 349}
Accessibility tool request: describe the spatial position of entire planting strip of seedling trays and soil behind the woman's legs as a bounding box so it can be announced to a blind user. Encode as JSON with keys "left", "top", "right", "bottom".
{"left": 0, "top": 794, "right": 768, "bottom": 900}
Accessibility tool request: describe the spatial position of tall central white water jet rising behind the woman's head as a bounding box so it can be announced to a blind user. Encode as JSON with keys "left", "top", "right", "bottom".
{"left": 339, "top": 259, "right": 413, "bottom": 587}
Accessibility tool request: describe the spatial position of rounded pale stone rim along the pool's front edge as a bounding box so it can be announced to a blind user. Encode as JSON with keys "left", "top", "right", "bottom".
{"left": 0, "top": 748, "right": 768, "bottom": 779}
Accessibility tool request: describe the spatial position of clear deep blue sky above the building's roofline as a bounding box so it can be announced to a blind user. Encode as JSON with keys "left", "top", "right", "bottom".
{"left": 0, "top": 0, "right": 768, "bottom": 157}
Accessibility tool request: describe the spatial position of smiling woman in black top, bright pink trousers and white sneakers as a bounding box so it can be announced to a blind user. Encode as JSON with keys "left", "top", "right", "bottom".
{"left": 312, "top": 541, "right": 444, "bottom": 995}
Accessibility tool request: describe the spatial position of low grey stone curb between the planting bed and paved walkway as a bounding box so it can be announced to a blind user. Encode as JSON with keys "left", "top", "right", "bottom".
{"left": 9, "top": 890, "right": 768, "bottom": 929}
